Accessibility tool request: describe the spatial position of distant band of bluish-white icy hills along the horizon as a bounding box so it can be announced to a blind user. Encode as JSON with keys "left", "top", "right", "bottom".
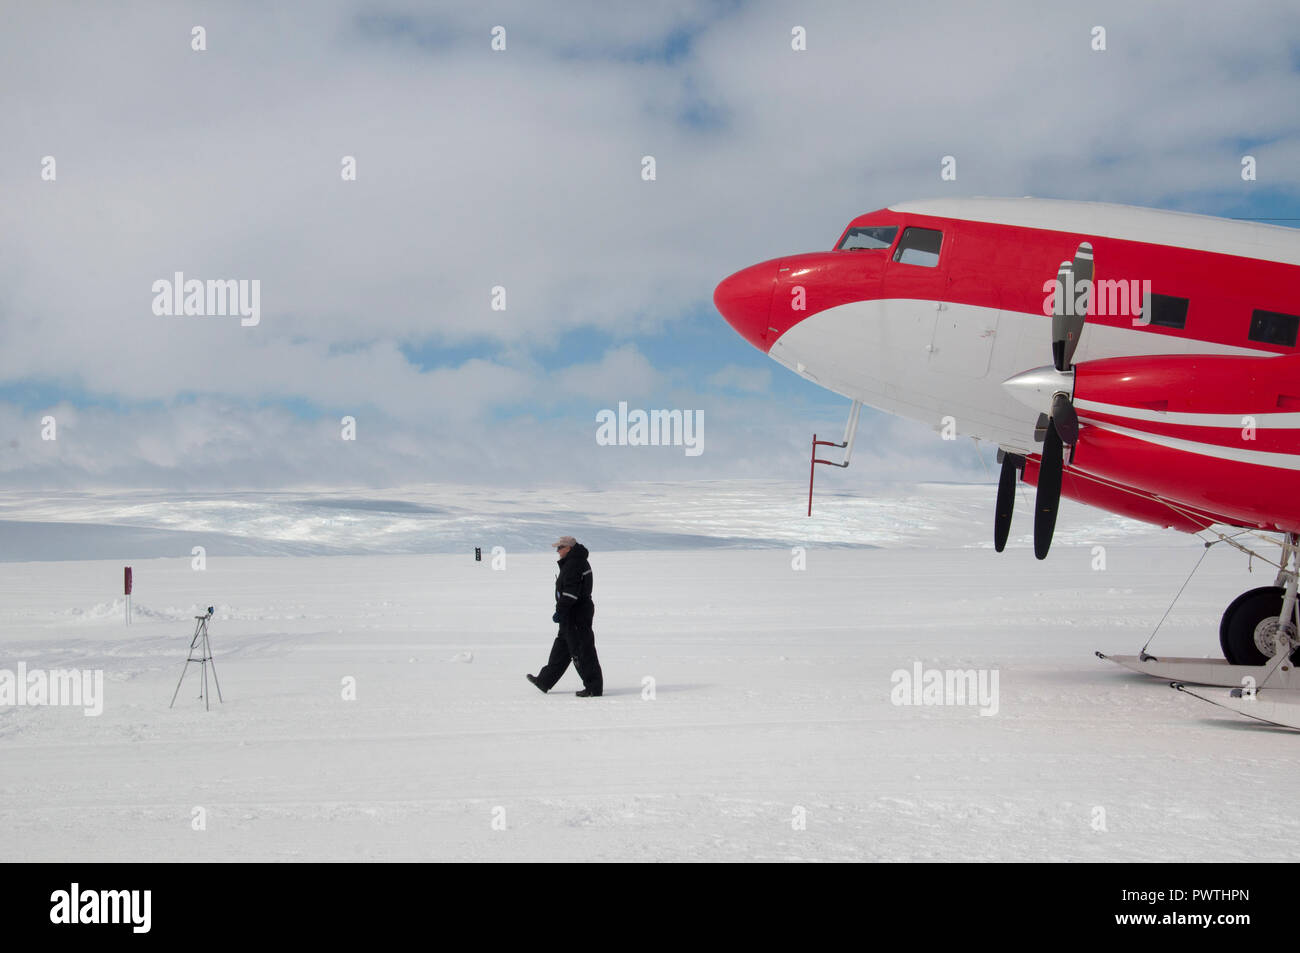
{"left": 0, "top": 481, "right": 1171, "bottom": 562}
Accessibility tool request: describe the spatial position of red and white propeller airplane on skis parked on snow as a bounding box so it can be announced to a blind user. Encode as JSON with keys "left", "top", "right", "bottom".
{"left": 714, "top": 199, "right": 1300, "bottom": 723}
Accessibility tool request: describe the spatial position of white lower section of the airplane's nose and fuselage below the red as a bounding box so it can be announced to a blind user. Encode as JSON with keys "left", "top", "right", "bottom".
{"left": 768, "top": 298, "right": 1268, "bottom": 454}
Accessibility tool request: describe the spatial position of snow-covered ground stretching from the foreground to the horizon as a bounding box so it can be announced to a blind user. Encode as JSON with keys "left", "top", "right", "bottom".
{"left": 0, "top": 484, "right": 1300, "bottom": 861}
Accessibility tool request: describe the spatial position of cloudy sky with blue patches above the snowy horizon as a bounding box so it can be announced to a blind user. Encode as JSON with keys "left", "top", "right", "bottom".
{"left": 0, "top": 0, "right": 1300, "bottom": 489}
